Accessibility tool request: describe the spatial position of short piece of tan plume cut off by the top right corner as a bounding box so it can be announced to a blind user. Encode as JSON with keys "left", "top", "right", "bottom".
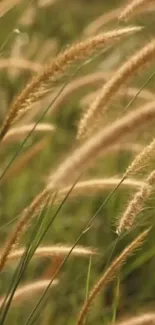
{"left": 118, "top": 0, "right": 154, "bottom": 21}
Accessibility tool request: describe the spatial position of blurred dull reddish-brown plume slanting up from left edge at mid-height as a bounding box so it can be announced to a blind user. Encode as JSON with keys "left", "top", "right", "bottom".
{"left": 2, "top": 137, "right": 48, "bottom": 183}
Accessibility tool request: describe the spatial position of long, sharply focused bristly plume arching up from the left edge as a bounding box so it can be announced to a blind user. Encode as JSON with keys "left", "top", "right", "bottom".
{"left": 0, "top": 27, "right": 141, "bottom": 140}
